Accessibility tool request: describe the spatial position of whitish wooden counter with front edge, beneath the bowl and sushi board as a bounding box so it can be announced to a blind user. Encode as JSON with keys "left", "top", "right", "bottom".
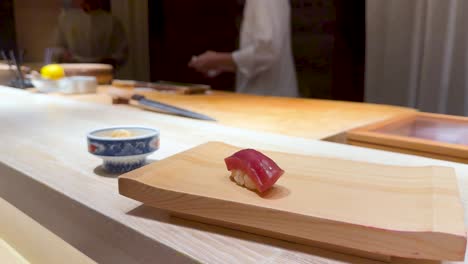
{"left": 0, "top": 88, "right": 468, "bottom": 264}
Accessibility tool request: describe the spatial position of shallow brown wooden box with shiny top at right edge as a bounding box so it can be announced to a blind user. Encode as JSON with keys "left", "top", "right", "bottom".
{"left": 346, "top": 113, "right": 468, "bottom": 163}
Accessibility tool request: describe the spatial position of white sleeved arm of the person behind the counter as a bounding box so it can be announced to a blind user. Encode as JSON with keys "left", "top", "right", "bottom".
{"left": 232, "top": 0, "right": 290, "bottom": 78}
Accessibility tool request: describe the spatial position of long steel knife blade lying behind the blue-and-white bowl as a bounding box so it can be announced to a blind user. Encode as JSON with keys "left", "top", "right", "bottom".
{"left": 131, "top": 94, "right": 216, "bottom": 121}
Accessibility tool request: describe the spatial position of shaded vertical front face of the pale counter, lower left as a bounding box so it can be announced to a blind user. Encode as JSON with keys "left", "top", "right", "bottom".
{"left": 0, "top": 162, "right": 196, "bottom": 264}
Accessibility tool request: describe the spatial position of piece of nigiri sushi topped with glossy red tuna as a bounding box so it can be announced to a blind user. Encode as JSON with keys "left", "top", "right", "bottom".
{"left": 224, "top": 149, "right": 284, "bottom": 193}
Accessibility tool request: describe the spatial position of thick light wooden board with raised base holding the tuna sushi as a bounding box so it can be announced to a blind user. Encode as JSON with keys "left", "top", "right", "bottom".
{"left": 119, "top": 142, "right": 466, "bottom": 260}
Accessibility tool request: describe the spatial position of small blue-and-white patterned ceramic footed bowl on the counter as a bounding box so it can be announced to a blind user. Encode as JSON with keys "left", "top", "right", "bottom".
{"left": 87, "top": 126, "right": 159, "bottom": 173}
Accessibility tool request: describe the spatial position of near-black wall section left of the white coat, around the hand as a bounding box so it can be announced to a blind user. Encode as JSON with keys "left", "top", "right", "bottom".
{"left": 148, "top": 0, "right": 242, "bottom": 90}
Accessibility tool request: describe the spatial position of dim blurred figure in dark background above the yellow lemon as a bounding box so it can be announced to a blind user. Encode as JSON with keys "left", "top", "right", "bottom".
{"left": 49, "top": 0, "right": 128, "bottom": 67}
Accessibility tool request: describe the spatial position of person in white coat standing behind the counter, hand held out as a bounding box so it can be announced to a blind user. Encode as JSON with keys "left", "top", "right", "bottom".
{"left": 189, "top": 0, "right": 298, "bottom": 97}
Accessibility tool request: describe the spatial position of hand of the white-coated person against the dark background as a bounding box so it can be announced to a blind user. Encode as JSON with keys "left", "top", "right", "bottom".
{"left": 189, "top": 51, "right": 236, "bottom": 77}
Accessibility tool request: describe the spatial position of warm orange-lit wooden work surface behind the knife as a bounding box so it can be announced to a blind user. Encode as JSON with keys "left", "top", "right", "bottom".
{"left": 67, "top": 86, "right": 415, "bottom": 139}
